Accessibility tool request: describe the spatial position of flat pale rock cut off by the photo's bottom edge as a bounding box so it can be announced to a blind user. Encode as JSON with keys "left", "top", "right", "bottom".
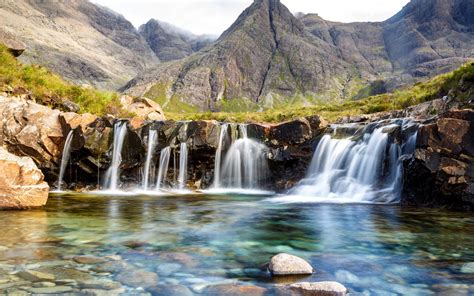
{"left": 288, "top": 282, "right": 348, "bottom": 296}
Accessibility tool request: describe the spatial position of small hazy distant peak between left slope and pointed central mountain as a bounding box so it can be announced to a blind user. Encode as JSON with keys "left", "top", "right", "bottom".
{"left": 139, "top": 19, "right": 215, "bottom": 62}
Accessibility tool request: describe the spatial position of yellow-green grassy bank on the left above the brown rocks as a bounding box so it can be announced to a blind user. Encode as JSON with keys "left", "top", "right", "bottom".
{"left": 0, "top": 44, "right": 129, "bottom": 116}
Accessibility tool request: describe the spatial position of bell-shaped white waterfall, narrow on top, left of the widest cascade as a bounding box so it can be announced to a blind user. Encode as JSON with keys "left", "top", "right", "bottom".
{"left": 216, "top": 125, "right": 268, "bottom": 189}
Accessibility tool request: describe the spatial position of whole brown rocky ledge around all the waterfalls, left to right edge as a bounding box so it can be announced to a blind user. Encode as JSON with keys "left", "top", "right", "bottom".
{"left": 0, "top": 96, "right": 474, "bottom": 210}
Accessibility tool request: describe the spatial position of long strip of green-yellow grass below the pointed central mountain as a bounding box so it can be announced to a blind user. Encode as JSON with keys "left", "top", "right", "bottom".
{"left": 166, "top": 63, "right": 474, "bottom": 122}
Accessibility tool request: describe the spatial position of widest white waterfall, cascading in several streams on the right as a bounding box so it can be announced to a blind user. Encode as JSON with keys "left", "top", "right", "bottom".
{"left": 287, "top": 120, "right": 417, "bottom": 203}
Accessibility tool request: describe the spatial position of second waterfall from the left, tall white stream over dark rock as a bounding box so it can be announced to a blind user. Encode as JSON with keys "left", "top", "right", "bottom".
{"left": 106, "top": 121, "right": 127, "bottom": 191}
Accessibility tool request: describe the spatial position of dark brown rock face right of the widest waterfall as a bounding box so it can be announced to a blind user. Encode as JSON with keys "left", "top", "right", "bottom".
{"left": 403, "top": 110, "right": 474, "bottom": 209}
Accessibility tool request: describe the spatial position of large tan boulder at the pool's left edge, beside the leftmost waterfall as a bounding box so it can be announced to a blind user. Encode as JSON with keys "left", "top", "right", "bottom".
{"left": 0, "top": 147, "right": 49, "bottom": 210}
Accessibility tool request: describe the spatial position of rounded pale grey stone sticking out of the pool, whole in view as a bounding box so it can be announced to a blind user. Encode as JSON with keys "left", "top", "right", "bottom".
{"left": 268, "top": 253, "right": 314, "bottom": 275}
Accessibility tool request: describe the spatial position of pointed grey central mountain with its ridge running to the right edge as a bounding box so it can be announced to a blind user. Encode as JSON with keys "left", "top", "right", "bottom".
{"left": 122, "top": 0, "right": 474, "bottom": 110}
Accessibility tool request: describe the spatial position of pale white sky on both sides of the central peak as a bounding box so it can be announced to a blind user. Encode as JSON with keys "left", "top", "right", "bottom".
{"left": 91, "top": 0, "right": 409, "bottom": 35}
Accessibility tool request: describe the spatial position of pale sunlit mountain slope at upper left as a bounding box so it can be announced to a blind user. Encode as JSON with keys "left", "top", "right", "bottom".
{"left": 0, "top": 0, "right": 159, "bottom": 89}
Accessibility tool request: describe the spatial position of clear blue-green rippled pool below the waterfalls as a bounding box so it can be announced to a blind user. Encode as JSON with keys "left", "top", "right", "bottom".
{"left": 0, "top": 194, "right": 474, "bottom": 295}
